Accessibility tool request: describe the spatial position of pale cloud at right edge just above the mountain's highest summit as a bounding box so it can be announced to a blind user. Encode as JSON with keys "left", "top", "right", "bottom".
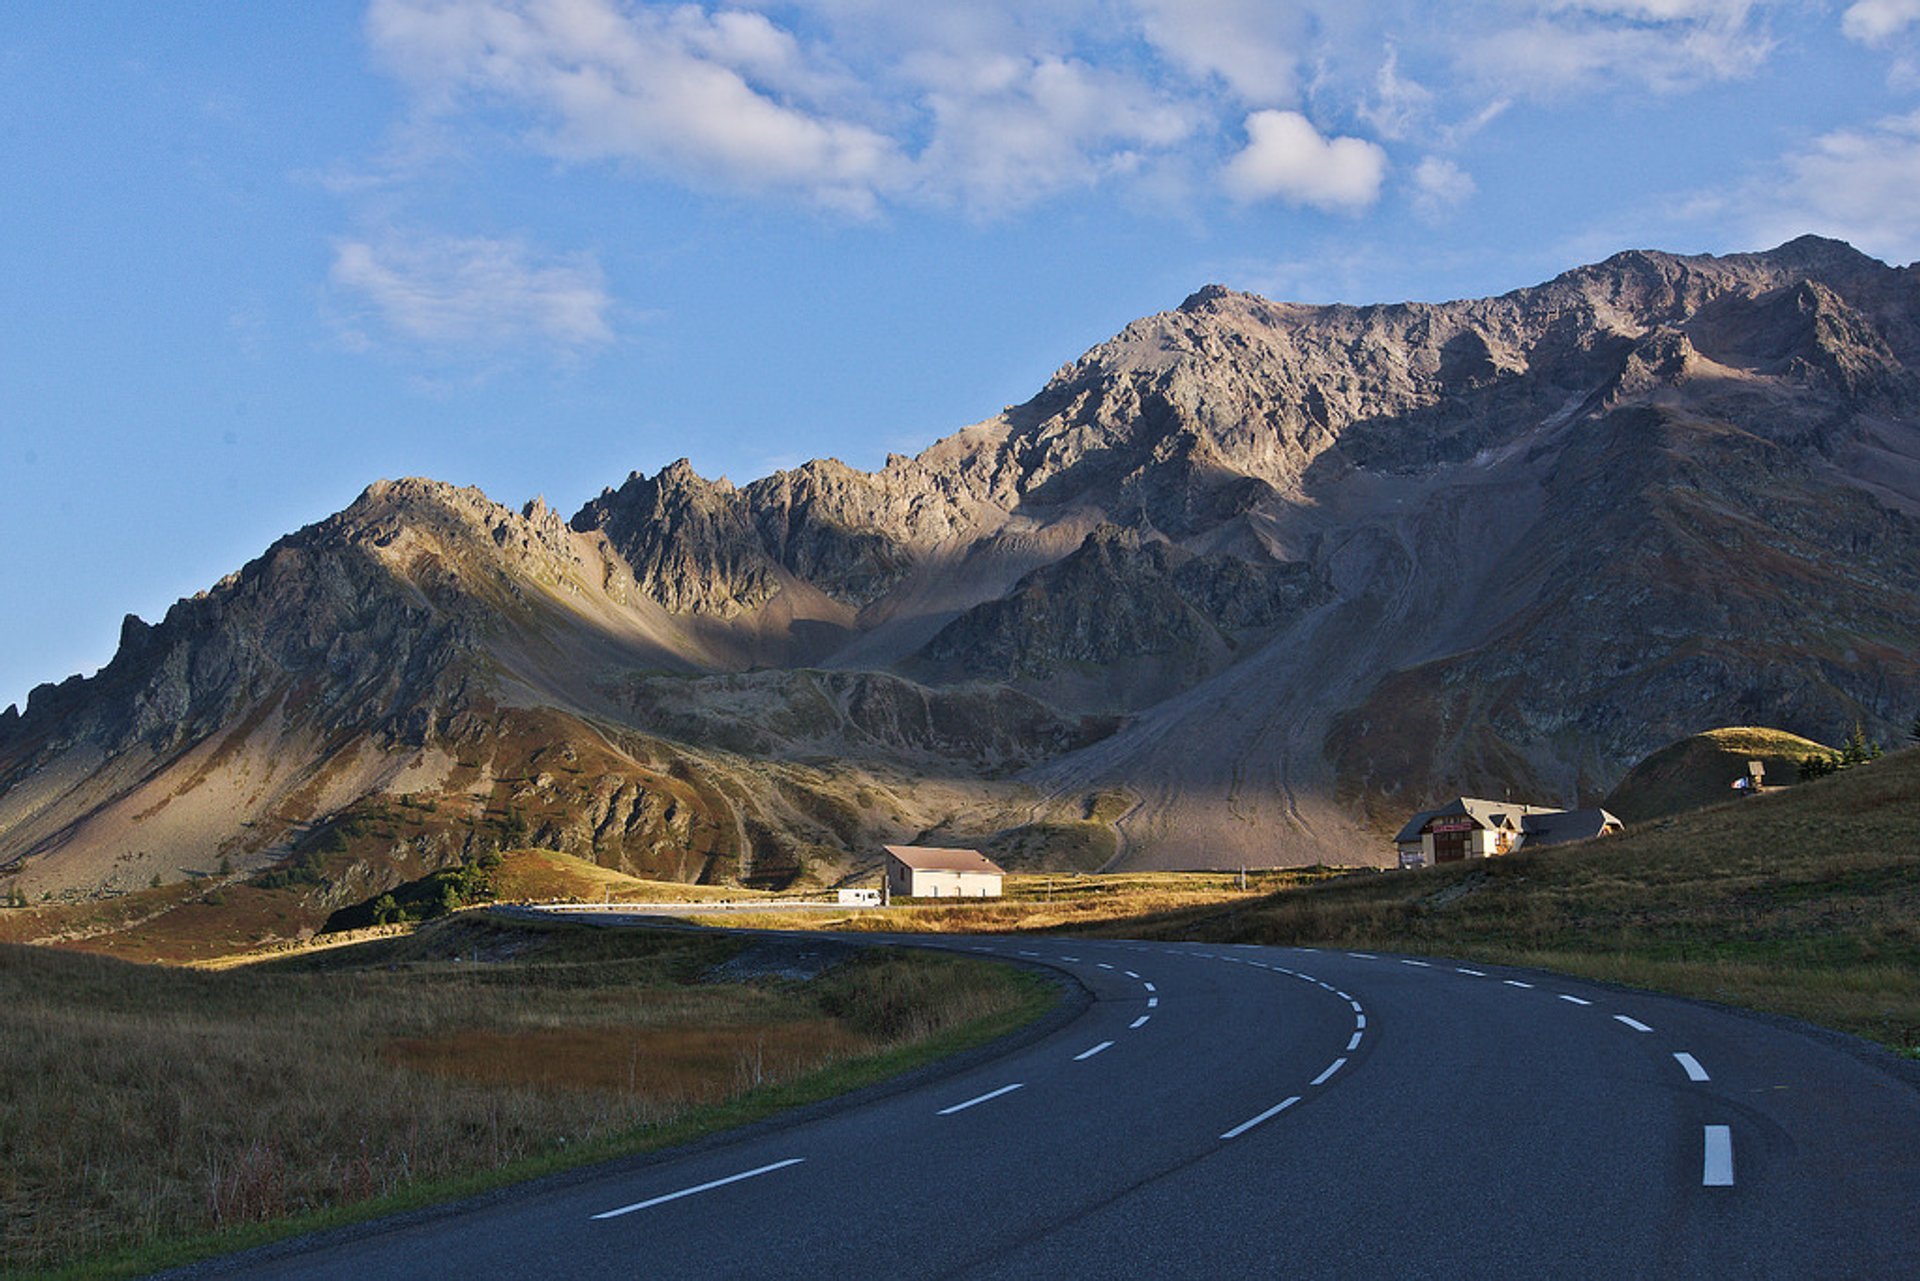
{"left": 1740, "top": 111, "right": 1920, "bottom": 261}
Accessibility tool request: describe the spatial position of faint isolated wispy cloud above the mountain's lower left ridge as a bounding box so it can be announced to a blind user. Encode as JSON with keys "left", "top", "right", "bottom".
{"left": 328, "top": 234, "right": 612, "bottom": 355}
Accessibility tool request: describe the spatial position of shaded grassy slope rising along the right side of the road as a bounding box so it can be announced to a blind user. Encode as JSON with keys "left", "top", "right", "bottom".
{"left": 1106, "top": 751, "right": 1920, "bottom": 1054}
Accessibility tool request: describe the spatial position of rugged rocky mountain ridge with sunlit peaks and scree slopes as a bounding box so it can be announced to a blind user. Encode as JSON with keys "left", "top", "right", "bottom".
{"left": 0, "top": 236, "right": 1920, "bottom": 910}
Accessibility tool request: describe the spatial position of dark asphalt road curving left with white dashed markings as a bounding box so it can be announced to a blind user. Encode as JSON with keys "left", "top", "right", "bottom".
{"left": 196, "top": 937, "right": 1920, "bottom": 1279}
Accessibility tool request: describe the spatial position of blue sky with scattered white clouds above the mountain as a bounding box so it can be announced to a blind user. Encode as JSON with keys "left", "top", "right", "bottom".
{"left": 0, "top": 0, "right": 1920, "bottom": 705}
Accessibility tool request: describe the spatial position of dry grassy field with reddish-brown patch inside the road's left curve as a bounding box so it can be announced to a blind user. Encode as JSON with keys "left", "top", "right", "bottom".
{"left": 0, "top": 914, "right": 1054, "bottom": 1275}
